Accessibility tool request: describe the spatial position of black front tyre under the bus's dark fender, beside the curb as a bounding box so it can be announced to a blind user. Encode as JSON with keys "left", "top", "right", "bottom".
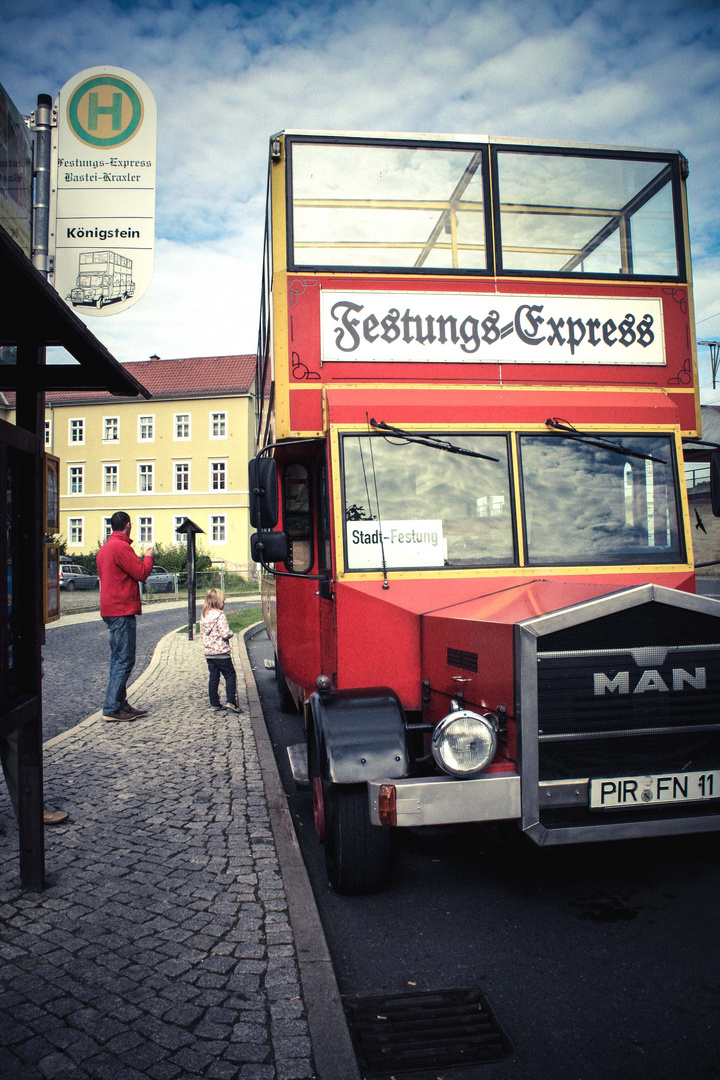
{"left": 325, "top": 784, "right": 392, "bottom": 895}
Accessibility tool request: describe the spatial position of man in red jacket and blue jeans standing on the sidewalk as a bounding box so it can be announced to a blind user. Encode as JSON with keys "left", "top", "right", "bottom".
{"left": 97, "top": 510, "right": 154, "bottom": 721}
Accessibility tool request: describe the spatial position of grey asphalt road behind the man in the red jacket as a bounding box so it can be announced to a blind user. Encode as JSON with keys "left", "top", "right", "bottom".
{"left": 42, "top": 593, "right": 258, "bottom": 741}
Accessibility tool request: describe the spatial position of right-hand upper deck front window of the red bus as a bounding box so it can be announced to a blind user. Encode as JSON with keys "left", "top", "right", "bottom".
{"left": 498, "top": 150, "right": 679, "bottom": 278}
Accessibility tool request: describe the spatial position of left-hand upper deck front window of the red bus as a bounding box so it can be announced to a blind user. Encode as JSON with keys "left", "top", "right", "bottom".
{"left": 291, "top": 141, "right": 487, "bottom": 271}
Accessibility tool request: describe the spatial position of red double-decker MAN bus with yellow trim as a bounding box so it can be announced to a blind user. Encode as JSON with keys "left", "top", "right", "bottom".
{"left": 250, "top": 132, "right": 720, "bottom": 892}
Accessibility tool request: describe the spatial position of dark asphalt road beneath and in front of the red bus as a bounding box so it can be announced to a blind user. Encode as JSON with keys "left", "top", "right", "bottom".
{"left": 250, "top": 632, "right": 720, "bottom": 1080}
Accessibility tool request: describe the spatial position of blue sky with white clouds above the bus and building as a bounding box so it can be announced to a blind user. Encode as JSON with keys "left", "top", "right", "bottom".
{"left": 0, "top": 0, "right": 720, "bottom": 393}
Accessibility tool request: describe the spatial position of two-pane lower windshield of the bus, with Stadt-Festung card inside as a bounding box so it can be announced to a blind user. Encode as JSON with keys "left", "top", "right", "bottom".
{"left": 341, "top": 432, "right": 684, "bottom": 570}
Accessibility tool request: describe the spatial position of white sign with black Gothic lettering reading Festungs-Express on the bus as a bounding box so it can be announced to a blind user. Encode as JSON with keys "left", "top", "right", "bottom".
{"left": 321, "top": 289, "right": 665, "bottom": 365}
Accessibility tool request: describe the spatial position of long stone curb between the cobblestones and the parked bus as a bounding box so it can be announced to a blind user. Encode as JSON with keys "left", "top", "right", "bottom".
{"left": 235, "top": 622, "right": 361, "bottom": 1080}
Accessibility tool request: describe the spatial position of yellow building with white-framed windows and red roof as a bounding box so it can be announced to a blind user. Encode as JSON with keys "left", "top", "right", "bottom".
{"left": 40, "top": 355, "right": 255, "bottom": 572}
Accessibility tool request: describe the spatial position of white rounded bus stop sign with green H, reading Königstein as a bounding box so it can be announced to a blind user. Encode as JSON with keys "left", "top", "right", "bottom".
{"left": 50, "top": 67, "right": 157, "bottom": 315}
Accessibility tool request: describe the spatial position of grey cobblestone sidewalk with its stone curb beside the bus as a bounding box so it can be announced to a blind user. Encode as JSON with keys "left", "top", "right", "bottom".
{"left": 0, "top": 633, "right": 357, "bottom": 1080}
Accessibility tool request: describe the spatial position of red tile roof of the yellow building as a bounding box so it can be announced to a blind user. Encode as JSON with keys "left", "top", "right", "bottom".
{"left": 45, "top": 353, "right": 255, "bottom": 405}
